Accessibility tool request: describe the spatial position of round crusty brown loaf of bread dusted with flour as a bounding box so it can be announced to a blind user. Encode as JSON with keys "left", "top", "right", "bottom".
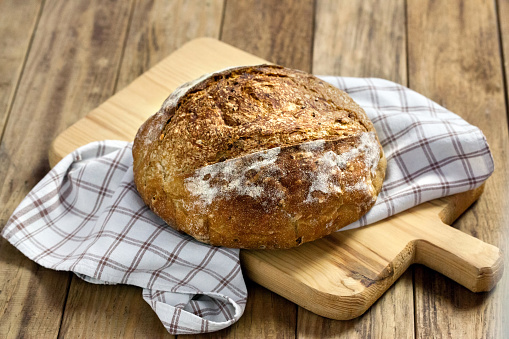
{"left": 133, "top": 65, "right": 386, "bottom": 249}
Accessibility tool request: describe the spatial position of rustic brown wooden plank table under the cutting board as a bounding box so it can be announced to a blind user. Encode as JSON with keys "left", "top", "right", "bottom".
{"left": 0, "top": 0, "right": 509, "bottom": 338}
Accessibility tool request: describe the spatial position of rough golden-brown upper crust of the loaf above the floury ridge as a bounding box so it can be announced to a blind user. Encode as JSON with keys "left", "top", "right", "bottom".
{"left": 133, "top": 65, "right": 374, "bottom": 181}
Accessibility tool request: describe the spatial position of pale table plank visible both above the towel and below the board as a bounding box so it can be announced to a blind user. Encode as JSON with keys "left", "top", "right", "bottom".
{"left": 297, "top": 0, "right": 414, "bottom": 338}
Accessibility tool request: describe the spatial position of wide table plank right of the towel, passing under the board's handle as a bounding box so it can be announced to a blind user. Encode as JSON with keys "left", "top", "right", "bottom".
{"left": 407, "top": 0, "right": 509, "bottom": 338}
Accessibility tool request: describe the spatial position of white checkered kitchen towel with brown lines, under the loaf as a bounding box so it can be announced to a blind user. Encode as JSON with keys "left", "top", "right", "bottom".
{"left": 2, "top": 77, "right": 493, "bottom": 334}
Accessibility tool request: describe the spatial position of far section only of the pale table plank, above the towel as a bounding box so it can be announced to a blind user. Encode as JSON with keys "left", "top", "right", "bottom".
{"left": 313, "top": 0, "right": 407, "bottom": 85}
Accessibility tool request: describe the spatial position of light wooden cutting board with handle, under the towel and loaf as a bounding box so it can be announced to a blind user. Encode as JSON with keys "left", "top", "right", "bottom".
{"left": 49, "top": 38, "right": 503, "bottom": 320}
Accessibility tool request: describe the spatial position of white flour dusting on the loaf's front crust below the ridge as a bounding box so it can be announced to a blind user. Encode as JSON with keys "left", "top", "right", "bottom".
{"left": 184, "top": 132, "right": 380, "bottom": 210}
